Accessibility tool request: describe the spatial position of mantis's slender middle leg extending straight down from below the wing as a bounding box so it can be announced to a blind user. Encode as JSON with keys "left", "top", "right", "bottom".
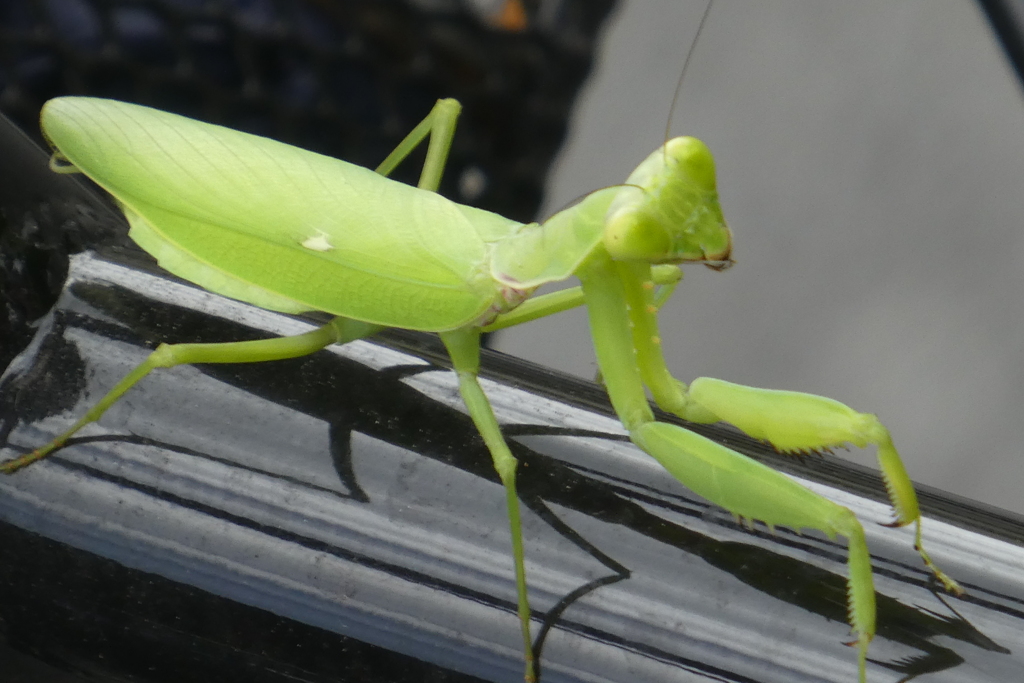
{"left": 440, "top": 329, "right": 537, "bottom": 683}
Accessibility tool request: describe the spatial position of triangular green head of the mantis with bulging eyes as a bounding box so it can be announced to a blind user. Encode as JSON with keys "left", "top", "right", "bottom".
{"left": 602, "top": 137, "right": 732, "bottom": 270}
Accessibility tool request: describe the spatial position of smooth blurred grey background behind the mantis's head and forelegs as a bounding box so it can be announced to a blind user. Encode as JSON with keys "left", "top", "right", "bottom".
{"left": 497, "top": 0, "right": 1024, "bottom": 512}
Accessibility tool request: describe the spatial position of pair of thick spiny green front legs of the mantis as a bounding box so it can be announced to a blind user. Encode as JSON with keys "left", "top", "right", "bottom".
{"left": 580, "top": 250, "right": 959, "bottom": 683}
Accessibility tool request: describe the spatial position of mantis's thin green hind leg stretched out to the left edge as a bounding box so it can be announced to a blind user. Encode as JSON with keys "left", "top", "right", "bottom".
{"left": 0, "top": 317, "right": 378, "bottom": 474}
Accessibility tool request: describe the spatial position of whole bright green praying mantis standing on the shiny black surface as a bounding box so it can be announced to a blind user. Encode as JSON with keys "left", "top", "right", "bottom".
{"left": 0, "top": 92, "right": 961, "bottom": 683}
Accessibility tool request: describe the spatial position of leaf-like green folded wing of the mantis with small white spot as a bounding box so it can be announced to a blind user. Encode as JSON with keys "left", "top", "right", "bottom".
{"left": 42, "top": 97, "right": 519, "bottom": 331}
